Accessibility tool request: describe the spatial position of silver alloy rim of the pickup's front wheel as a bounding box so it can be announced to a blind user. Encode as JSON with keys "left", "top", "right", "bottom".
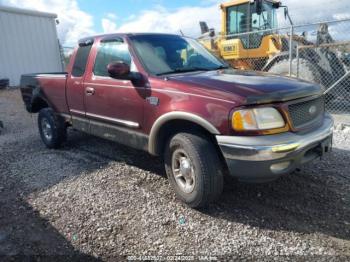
{"left": 172, "top": 149, "right": 196, "bottom": 193}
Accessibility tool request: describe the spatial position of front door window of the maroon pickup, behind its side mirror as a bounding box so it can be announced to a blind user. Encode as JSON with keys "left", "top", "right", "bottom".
{"left": 94, "top": 41, "right": 131, "bottom": 76}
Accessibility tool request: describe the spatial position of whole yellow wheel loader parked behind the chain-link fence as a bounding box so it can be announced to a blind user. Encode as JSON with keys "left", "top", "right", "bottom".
{"left": 198, "top": 0, "right": 345, "bottom": 90}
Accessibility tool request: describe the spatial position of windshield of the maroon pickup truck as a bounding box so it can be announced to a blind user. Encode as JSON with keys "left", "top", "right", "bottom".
{"left": 130, "top": 35, "right": 227, "bottom": 75}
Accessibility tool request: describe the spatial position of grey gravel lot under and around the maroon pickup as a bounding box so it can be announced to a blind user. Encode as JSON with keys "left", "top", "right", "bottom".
{"left": 0, "top": 90, "right": 350, "bottom": 261}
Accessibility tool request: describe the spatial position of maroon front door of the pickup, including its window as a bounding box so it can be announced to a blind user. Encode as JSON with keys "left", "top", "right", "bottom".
{"left": 84, "top": 37, "right": 145, "bottom": 148}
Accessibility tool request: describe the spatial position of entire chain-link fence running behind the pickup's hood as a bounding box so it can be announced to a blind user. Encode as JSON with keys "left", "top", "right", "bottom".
{"left": 199, "top": 19, "right": 350, "bottom": 123}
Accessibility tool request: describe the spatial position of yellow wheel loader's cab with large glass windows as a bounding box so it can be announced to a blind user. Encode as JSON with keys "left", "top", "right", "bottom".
{"left": 218, "top": 0, "right": 282, "bottom": 69}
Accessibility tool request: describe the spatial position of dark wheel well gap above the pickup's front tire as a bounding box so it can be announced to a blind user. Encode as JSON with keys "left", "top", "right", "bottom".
{"left": 155, "top": 119, "right": 217, "bottom": 156}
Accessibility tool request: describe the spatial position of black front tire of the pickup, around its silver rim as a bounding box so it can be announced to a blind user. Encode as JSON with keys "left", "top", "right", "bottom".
{"left": 164, "top": 133, "right": 223, "bottom": 208}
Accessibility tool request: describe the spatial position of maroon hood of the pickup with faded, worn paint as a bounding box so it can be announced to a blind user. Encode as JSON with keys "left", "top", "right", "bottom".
{"left": 170, "top": 69, "right": 323, "bottom": 104}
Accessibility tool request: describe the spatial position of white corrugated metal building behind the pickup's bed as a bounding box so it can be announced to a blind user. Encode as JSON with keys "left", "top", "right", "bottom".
{"left": 0, "top": 6, "right": 63, "bottom": 86}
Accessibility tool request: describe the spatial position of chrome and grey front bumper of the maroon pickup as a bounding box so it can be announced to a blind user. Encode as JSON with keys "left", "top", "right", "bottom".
{"left": 216, "top": 115, "right": 333, "bottom": 180}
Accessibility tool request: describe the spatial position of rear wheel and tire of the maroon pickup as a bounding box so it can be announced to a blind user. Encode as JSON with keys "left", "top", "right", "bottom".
{"left": 38, "top": 108, "right": 67, "bottom": 149}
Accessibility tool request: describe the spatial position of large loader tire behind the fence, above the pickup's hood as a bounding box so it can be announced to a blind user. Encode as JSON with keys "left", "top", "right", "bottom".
{"left": 269, "top": 58, "right": 322, "bottom": 84}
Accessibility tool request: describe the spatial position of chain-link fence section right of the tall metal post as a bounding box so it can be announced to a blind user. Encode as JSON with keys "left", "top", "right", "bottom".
{"left": 291, "top": 20, "right": 350, "bottom": 115}
